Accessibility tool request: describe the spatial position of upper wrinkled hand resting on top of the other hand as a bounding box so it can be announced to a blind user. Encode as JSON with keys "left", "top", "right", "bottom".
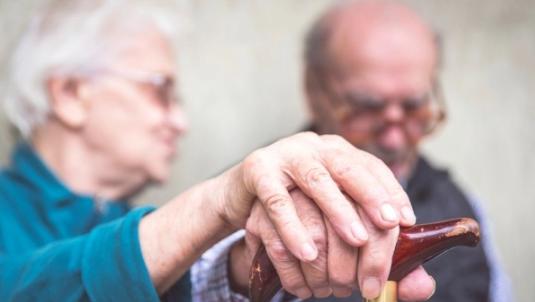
{"left": 221, "top": 133, "right": 416, "bottom": 262}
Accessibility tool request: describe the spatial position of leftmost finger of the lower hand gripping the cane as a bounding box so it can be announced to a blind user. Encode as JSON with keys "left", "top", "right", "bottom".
{"left": 247, "top": 203, "right": 312, "bottom": 299}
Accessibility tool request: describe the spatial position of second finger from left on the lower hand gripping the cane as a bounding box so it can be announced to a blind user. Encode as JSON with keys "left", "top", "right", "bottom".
{"left": 290, "top": 189, "right": 331, "bottom": 298}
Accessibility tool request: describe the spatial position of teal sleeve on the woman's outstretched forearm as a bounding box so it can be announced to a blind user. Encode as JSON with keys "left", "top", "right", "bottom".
{"left": 0, "top": 208, "right": 163, "bottom": 301}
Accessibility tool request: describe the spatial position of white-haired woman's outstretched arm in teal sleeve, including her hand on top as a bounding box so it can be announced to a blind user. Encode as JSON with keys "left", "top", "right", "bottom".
{"left": 0, "top": 134, "right": 430, "bottom": 301}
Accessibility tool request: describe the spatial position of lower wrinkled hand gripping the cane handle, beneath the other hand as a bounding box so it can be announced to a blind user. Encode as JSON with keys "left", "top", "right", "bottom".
{"left": 239, "top": 190, "right": 434, "bottom": 301}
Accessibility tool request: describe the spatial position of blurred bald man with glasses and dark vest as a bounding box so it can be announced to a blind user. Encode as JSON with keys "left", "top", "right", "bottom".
{"left": 305, "top": 1, "right": 511, "bottom": 302}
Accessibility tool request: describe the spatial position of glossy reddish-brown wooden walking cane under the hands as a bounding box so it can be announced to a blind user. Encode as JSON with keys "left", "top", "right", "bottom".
{"left": 249, "top": 218, "right": 479, "bottom": 302}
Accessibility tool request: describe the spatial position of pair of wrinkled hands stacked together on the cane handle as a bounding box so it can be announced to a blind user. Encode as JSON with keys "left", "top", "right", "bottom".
{"left": 224, "top": 133, "right": 434, "bottom": 300}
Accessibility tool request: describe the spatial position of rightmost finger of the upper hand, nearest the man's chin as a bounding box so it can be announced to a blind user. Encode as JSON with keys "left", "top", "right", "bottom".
{"left": 367, "top": 158, "right": 416, "bottom": 226}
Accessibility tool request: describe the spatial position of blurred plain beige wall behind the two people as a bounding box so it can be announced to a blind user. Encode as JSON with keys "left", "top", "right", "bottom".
{"left": 0, "top": 0, "right": 535, "bottom": 301}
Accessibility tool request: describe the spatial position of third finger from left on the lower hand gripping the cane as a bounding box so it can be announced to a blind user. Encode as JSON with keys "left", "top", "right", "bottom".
{"left": 325, "top": 219, "right": 358, "bottom": 297}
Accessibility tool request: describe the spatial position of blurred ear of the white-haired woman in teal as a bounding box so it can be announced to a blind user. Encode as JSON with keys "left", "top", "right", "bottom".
{"left": 47, "top": 76, "right": 87, "bottom": 129}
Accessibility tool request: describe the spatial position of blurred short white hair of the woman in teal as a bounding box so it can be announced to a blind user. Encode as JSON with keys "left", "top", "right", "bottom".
{"left": 4, "top": 0, "right": 182, "bottom": 137}
